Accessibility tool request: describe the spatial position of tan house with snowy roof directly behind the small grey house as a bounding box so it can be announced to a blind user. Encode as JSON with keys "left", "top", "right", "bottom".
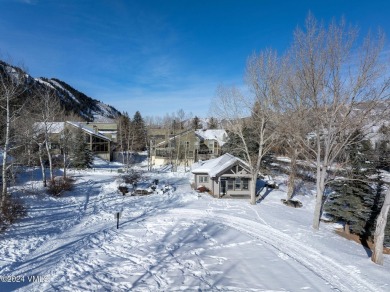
{"left": 149, "top": 129, "right": 228, "bottom": 166}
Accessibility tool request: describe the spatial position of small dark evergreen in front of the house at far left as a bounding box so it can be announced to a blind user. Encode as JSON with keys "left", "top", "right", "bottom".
{"left": 71, "top": 128, "right": 93, "bottom": 168}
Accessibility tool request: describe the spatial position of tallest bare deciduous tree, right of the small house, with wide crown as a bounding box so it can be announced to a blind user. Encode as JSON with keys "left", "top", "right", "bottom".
{"left": 289, "top": 15, "right": 390, "bottom": 229}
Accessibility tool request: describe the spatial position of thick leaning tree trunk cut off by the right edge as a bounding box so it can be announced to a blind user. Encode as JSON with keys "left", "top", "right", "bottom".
{"left": 371, "top": 189, "right": 390, "bottom": 265}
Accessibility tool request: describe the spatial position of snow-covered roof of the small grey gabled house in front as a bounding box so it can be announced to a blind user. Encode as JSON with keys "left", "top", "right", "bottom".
{"left": 192, "top": 153, "right": 248, "bottom": 177}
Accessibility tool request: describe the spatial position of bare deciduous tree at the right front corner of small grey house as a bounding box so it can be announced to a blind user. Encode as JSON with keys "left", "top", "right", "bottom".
{"left": 213, "top": 50, "right": 283, "bottom": 204}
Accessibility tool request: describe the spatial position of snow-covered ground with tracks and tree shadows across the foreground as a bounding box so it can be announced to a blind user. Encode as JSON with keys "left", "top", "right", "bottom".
{"left": 0, "top": 159, "right": 390, "bottom": 291}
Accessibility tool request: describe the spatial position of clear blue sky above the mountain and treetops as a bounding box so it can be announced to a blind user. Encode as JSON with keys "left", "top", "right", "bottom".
{"left": 0, "top": 0, "right": 390, "bottom": 117}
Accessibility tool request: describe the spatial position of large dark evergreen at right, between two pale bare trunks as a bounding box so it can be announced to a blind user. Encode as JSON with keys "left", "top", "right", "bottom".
{"left": 325, "top": 131, "right": 375, "bottom": 236}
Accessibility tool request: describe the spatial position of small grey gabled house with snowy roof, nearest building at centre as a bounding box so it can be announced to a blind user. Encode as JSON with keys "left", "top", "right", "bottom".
{"left": 192, "top": 153, "right": 251, "bottom": 198}
